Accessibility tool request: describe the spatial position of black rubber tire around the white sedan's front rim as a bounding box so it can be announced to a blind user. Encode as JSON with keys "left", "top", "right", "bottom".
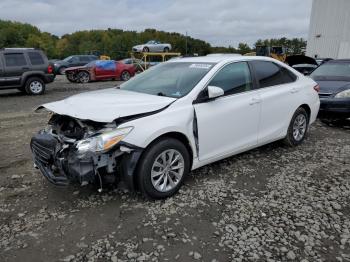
{"left": 136, "top": 137, "right": 190, "bottom": 199}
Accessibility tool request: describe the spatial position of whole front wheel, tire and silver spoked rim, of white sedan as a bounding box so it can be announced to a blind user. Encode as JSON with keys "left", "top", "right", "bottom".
{"left": 136, "top": 138, "right": 190, "bottom": 199}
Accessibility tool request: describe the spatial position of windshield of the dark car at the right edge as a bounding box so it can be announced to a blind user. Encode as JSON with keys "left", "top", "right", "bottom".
{"left": 310, "top": 63, "right": 350, "bottom": 78}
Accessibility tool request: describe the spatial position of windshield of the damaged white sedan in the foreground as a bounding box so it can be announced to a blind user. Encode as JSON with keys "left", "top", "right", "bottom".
{"left": 120, "top": 62, "right": 214, "bottom": 98}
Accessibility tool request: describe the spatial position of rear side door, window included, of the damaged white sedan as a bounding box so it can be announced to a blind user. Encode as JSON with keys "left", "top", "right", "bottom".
{"left": 250, "top": 61, "right": 302, "bottom": 144}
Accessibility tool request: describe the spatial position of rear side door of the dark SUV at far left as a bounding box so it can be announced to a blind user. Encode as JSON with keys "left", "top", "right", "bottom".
{"left": 4, "top": 52, "right": 30, "bottom": 86}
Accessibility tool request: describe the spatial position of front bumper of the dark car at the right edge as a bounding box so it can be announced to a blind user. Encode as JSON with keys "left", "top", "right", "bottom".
{"left": 318, "top": 98, "right": 350, "bottom": 118}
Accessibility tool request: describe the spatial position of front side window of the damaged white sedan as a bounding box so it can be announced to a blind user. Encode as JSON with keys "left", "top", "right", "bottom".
{"left": 209, "top": 62, "right": 253, "bottom": 95}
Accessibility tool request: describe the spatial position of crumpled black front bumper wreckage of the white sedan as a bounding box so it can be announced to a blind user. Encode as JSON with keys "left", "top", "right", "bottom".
{"left": 30, "top": 130, "right": 142, "bottom": 189}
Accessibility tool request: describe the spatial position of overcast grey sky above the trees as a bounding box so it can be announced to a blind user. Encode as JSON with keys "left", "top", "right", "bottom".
{"left": 0, "top": 0, "right": 312, "bottom": 46}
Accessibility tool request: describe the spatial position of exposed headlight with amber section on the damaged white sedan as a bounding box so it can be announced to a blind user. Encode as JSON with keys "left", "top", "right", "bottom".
{"left": 76, "top": 127, "right": 133, "bottom": 154}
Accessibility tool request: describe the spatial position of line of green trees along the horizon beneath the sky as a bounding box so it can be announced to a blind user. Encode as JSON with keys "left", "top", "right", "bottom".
{"left": 0, "top": 20, "right": 306, "bottom": 59}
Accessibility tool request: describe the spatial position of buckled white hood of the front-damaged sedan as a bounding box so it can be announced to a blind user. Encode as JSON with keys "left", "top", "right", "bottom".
{"left": 37, "top": 88, "right": 176, "bottom": 123}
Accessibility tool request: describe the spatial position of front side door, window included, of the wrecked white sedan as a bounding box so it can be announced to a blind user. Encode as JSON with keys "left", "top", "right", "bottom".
{"left": 194, "top": 62, "right": 260, "bottom": 161}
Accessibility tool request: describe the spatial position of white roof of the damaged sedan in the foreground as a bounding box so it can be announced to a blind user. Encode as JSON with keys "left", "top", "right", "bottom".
{"left": 169, "top": 55, "right": 277, "bottom": 63}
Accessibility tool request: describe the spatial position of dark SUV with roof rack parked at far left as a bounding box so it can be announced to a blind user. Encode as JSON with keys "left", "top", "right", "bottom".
{"left": 0, "top": 48, "right": 55, "bottom": 95}
